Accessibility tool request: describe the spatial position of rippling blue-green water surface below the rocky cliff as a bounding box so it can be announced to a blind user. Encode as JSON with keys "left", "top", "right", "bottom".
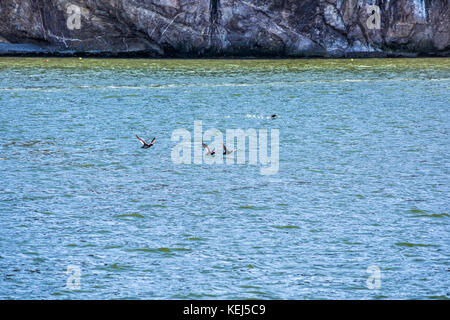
{"left": 0, "top": 58, "right": 450, "bottom": 299}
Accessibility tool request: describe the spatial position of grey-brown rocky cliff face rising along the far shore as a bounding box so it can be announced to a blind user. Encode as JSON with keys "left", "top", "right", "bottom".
{"left": 0, "top": 0, "right": 450, "bottom": 57}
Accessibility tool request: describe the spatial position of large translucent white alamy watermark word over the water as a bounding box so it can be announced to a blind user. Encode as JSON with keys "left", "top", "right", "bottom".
{"left": 171, "top": 120, "right": 280, "bottom": 175}
